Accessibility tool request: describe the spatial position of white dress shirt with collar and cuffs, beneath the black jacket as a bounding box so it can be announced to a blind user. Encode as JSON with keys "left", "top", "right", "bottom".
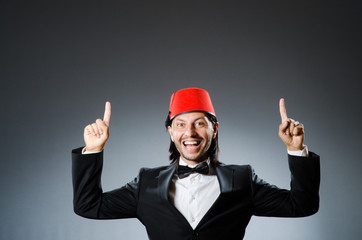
{"left": 82, "top": 146, "right": 308, "bottom": 229}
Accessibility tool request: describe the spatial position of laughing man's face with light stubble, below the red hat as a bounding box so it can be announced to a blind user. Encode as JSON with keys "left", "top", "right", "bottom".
{"left": 168, "top": 112, "right": 219, "bottom": 165}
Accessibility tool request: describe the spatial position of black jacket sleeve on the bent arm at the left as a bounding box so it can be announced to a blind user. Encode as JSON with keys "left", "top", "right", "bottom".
{"left": 72, "top": 148, "right": 142, "bottom": 219}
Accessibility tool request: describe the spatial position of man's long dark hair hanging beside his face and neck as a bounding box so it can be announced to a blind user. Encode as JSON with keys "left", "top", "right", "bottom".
{"left": 165, "top": 113, "right": 220, "bottom": 166}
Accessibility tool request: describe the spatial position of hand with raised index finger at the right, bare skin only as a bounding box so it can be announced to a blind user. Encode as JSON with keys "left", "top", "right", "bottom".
{"left": 279, "top": 98, "right": 304, "bottom": 151}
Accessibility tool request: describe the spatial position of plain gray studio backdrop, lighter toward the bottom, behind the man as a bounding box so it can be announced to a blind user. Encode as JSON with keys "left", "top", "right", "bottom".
{"left": 0, "top": 0, "right": 362, "bottom": 240}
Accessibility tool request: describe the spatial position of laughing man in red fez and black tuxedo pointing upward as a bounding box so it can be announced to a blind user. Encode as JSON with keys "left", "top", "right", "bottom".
{"left": 72, "top": 88, "right": 320, "bottom": 240}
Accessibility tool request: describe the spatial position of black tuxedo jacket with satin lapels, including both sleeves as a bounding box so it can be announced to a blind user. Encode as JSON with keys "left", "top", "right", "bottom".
{"left": 72, "top": 148, "right": 320, "bottom": 240}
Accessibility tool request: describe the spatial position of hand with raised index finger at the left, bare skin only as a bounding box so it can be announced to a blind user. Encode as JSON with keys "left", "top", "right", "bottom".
{"left": 84, "top": 102, "right": 111, "bottom": 152}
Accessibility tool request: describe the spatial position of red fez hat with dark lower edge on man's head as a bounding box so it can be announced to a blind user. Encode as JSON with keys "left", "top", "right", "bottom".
{"left": 168, "top": 88, "right": 216, "bottom": 120}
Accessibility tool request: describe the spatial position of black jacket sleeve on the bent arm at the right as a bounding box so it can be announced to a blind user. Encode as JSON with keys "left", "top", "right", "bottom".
{"left": 251, "top": 152, "right": 320, "bottom": 217}
